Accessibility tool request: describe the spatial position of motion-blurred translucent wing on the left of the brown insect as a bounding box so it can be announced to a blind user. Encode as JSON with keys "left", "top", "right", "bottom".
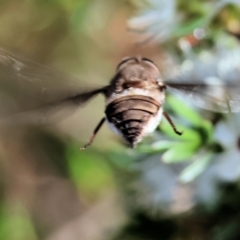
{"left": 0, "top": 49, "right": 104, "bottom": 122}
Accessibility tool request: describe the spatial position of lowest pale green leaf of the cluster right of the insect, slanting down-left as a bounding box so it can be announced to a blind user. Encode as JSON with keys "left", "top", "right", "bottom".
{"left": 180, "top": 153, "right": 213, "bottom": 183}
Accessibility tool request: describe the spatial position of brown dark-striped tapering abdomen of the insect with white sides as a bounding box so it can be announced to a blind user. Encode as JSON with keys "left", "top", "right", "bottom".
{"left": 105, "top": 95, "right": 162, "bottom": 147}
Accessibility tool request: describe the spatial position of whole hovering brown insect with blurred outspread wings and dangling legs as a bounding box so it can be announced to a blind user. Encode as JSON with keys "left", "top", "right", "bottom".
{"left": 0, "top": 50, "right": 240, "bottom": 150}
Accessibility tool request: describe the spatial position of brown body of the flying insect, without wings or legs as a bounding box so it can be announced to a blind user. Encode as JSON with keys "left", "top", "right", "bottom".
{"left": 105, "top": 57, "right": 165, "bottom": 147}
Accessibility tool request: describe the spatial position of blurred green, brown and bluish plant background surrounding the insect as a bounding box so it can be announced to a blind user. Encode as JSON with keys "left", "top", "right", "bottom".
{"left": 0, "top": 0, "right": 240, "bottom": 240}
